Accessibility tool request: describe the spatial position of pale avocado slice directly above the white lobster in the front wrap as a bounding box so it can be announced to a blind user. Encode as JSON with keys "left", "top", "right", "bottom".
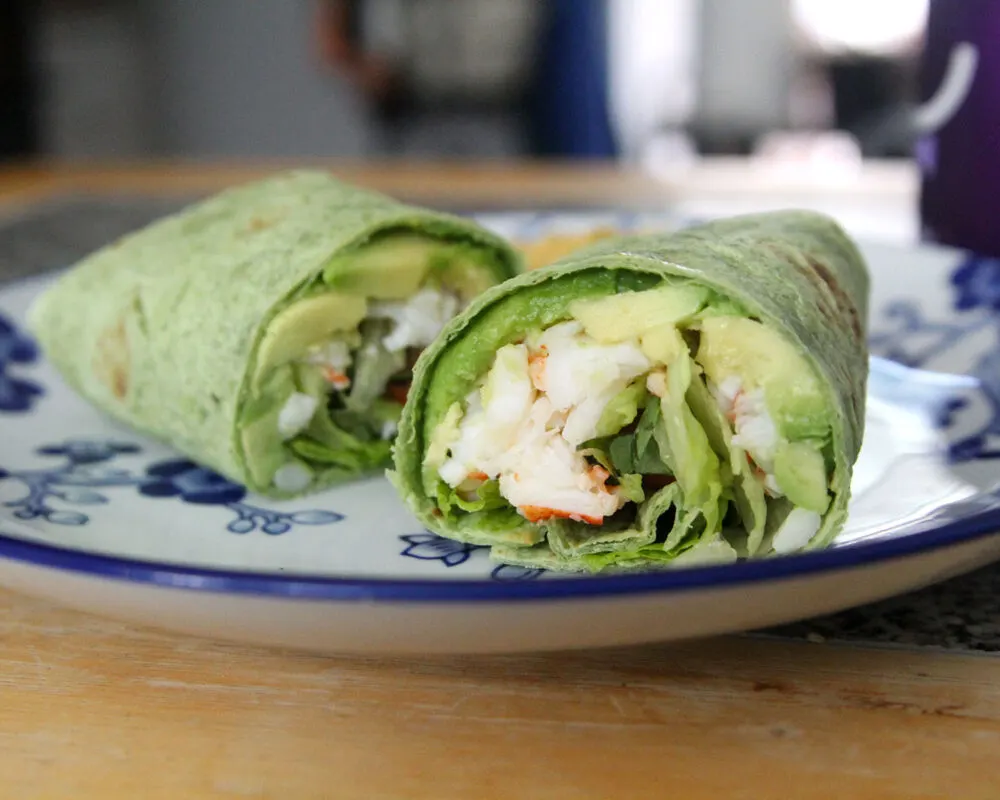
{"left": 569, "top": 283, "right": 709, "bottom": 344}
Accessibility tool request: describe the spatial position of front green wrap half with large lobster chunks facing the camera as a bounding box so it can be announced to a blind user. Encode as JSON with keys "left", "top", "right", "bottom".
{"left": 390, "top": 211, "right": 868, "bottom": 571}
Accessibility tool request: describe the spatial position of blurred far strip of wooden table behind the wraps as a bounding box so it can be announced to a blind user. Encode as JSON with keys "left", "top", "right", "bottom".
{"left": 0, "top": 158, "right": 918, "bottom": 208}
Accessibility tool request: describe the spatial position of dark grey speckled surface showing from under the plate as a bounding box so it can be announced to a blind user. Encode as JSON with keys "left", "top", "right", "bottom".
{"left": 0, "top": 197, "right": 1000, "bottom": 653}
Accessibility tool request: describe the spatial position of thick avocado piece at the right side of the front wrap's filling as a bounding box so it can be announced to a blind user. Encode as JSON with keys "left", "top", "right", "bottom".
{"left": 696, "top": 317, "right": 830, "bottom": 441}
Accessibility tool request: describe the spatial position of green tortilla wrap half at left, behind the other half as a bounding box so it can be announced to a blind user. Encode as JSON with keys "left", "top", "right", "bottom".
{"left": 31, "top": 172, "right": 520, "bottom": 497}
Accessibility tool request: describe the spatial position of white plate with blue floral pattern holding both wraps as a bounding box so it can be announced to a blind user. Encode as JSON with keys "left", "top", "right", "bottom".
{"left": 0, "top": 214, "right": 1000, "bottom": 653}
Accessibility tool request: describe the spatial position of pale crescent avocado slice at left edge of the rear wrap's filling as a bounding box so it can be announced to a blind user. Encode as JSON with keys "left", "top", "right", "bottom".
{"left": 254, "top": 292, "right": 368, "bottom": 385}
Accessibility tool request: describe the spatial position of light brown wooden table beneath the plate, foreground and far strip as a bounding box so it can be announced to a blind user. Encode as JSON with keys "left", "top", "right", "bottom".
{"left": 0, "top": 159, "right": 1000, "bottom": 800}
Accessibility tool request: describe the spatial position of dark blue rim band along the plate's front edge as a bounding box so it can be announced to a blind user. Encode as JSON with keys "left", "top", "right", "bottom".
{"left": 0, "top": 508, "right": 1000, "bottom": 603}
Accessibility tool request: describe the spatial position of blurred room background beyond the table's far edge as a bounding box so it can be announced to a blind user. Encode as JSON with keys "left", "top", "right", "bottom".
{"left": 0, "top": 0, "right": 927, "bottom": 169}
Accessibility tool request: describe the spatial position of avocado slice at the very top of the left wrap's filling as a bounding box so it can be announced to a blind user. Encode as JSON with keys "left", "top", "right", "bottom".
{"left": 323, "top": 238, "right": 442, "bottom": 300}
